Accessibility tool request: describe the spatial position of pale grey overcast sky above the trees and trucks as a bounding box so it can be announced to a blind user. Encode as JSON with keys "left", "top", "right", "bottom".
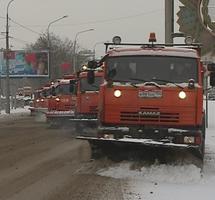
{"left": 0, "top": 0, "right": 181, "bottom": 55}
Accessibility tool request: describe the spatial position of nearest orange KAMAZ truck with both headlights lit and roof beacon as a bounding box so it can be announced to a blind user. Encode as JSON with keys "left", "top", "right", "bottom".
{"left": 78, "top": 33, "right": 214, "bottom": 167}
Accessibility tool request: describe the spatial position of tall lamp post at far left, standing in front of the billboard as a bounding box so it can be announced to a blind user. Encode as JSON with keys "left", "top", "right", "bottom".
{"left": 5, "top": 0, "right": 14, "bottom": 114}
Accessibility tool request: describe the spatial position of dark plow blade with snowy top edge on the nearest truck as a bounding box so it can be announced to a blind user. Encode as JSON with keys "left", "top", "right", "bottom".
{"left": 76, "top": 136, "right": 203, "bottom": 170}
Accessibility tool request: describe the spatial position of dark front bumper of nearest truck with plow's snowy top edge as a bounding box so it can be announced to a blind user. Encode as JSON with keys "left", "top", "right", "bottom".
{"left": 78, "top": 126, "right": 202, "bottom": 149}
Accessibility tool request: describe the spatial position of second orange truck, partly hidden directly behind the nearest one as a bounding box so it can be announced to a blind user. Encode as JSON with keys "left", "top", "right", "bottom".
{"left": 70, "top": 68, "right": 104, "bottom": 134}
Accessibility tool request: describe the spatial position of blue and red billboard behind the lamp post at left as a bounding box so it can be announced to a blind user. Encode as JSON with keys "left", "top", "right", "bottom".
{"left": 0, "top": 50, "right": 49, "bottom": 77}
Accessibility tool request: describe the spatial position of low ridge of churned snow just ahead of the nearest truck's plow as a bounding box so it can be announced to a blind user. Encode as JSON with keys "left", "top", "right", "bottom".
{"left": 97, "top": 163, "right": 201, "bottom": 183}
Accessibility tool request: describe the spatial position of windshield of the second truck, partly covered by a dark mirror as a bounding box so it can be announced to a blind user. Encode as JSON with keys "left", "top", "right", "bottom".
{"left": 80, "top": 77, "right": 103, "bottom": 92}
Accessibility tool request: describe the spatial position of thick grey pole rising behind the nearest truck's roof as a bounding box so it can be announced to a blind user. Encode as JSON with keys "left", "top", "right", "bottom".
{"left": 165, "top": 0, "right": 174, "bottom": 43}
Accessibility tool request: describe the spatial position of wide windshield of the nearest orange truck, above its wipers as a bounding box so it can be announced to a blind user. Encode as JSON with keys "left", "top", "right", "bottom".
{"left": 107, "top": 56, "right": 198, "bottom": 84}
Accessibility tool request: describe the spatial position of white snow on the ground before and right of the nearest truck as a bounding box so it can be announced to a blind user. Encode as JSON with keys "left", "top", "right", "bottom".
{"left": 97, "top": 101, "right": 215, "bottom": 200}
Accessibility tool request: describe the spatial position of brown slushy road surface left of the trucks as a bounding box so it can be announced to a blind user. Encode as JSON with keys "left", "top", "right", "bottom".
{"left": 0, "top": 116, "right": 124, "bottom": 200}
